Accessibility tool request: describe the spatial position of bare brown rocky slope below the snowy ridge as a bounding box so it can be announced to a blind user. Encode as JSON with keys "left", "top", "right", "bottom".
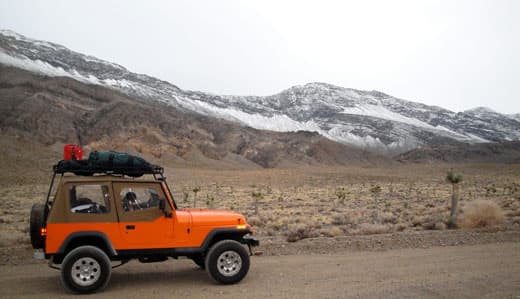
{"left": 0, "top": 65, "right": 387, "bottom": 167}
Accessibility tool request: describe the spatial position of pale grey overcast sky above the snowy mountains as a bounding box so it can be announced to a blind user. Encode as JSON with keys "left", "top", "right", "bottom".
{"left": 0, "top": 0, "right": 520, "bottom": 113}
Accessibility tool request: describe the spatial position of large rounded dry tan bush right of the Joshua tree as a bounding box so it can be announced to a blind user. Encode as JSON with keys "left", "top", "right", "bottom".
{"left": 458, "top": 200, "right": 504, "bottom": 228}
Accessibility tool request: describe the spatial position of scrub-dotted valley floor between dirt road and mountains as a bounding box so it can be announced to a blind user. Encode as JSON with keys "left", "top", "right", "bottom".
{"left": 0, "top": 164, "right": 520, "bottom": 248}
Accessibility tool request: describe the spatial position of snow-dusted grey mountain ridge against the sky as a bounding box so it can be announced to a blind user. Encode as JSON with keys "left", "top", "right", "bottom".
{"left": 0, "top": 30, "right": 520, "bottom": 153}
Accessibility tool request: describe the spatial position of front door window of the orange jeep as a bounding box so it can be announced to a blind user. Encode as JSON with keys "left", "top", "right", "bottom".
{"left": 119, "top": 187, "right": 159, "bottom": 212}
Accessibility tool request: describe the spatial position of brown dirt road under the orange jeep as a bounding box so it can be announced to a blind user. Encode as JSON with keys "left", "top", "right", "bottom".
{"left": 0, "top": 242, "right": 520, "bottom": 298}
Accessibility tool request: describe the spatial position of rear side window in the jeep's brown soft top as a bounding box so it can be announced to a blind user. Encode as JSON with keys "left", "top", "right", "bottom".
{"left": 69, "top": 184, "right": 110, "bottom": 214}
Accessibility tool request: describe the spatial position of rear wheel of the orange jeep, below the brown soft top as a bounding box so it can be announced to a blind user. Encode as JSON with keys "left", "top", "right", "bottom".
{"left": 61, "top": 246, "right": 112, "bottom": 294}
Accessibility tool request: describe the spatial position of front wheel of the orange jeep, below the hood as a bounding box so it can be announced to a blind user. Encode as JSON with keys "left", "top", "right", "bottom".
{"left": 206, "top": 240, "right": 249, "bottom": 284}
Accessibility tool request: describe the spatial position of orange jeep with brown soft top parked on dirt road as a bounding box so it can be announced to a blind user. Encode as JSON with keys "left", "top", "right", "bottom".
{"left": 30, "top": 154, "right": 259, "bottom": 293}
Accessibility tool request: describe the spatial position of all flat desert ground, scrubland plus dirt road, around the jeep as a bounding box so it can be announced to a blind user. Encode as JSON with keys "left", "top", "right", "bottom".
{"left": 0, "top": 164, "right": 520, "bottom": 298}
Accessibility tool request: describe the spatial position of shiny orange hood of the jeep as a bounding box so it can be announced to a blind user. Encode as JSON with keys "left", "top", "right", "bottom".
{"left": 183, "top": 208, "right": 247, "bottom": 226}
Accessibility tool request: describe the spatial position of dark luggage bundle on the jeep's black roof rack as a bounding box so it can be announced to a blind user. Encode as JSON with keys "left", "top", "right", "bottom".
{"left": 53, "top": 151, "right": 164, "bottom": 177}
